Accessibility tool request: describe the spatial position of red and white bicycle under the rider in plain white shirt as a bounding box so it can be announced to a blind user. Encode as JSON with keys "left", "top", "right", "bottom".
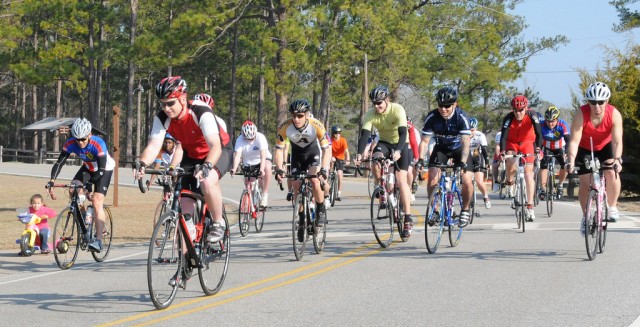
{"left": 238, "top": 166, "right": 267, "bottom": 237}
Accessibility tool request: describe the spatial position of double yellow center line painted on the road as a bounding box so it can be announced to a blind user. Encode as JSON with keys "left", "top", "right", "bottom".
{"left": 98, "top": 242, "right": 381, "bottom": 326}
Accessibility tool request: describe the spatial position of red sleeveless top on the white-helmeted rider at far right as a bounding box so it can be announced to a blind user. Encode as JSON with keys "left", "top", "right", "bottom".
{"left": 580, "top": 103, "right": 616, "bottom": 151}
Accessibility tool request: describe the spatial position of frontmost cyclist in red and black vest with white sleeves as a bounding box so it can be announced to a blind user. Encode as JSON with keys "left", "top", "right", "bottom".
{"left": 136, "top": 76, "right": 228, "bottom": 243}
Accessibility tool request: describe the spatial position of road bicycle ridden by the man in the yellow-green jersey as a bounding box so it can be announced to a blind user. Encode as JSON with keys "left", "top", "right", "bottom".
{"left": 369, "top": 157, "right": 408, "bottom": 248}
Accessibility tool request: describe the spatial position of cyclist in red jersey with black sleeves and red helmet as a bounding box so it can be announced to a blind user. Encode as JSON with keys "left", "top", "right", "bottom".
{"left": 500, "top": 94, "right": 542, "bottom": 221}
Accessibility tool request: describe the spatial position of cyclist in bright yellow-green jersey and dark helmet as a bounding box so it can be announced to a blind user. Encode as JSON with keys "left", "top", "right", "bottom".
{"left": 356, "top": 86, "right": 413, "bottom": 238}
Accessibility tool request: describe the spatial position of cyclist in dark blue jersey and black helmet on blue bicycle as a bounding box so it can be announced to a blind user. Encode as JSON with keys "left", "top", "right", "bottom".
{"left": 418, "top": 86, "right": 473, "bottom": 227}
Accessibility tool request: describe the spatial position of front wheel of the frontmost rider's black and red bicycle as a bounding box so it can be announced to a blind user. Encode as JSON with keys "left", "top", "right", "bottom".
{"left": 147, "top": 211, "right": 184, "bottom": 310}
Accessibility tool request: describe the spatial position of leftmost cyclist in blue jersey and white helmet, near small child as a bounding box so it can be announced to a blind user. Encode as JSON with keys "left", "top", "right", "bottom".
{"left": 45, "top": 118, "right": 116, "bottom": 252}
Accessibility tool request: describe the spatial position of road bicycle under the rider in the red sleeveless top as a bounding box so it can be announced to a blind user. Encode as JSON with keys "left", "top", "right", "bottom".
{"left": 583, "top": 139, "right": 615, "bottom": 260}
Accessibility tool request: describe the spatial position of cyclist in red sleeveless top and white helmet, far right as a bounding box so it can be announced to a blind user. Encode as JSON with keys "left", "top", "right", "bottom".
{"left": 566, "top": 82, "right": 622, "bottom": 235}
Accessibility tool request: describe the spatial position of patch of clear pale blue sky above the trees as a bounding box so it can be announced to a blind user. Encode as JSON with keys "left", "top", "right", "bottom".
{"left": 509, "top": 0, "right": 640, "bottom": 108}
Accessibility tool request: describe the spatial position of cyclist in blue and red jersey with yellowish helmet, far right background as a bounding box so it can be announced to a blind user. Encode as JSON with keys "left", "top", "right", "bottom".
{"left": 539, "top": 106, "right": 570, "bottom": 201}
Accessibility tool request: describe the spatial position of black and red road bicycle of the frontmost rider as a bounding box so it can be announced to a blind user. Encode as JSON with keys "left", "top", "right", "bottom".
{"left": 139, "top": 168, "right": 230, "bottom": 310}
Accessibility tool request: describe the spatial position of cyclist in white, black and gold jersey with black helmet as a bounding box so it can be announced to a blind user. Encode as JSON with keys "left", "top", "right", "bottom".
{"left": 275, "top": 100, "right": 331, "bottom": 224}
